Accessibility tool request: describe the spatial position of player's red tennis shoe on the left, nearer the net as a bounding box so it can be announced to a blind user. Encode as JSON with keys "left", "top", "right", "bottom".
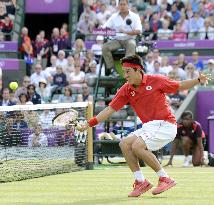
{"left": 128, "top": 179, "right": 152, "bottom": 197}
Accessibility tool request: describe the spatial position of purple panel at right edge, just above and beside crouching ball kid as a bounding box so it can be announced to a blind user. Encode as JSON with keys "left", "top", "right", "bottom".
{"left": 196, "top": 90, "right": 214, "bottom": 135}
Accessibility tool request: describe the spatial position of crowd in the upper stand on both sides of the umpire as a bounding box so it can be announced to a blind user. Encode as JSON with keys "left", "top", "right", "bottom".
{"left": 77, "top": 0, "right": 214, "bottom": 40}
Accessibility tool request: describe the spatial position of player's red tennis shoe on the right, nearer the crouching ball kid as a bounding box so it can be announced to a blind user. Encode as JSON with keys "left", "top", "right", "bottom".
{"left": 152, "top": 177, "right": 176, "bottom": 195}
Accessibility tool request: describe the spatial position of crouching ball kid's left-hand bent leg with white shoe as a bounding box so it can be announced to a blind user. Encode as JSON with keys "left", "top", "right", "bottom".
{"left": 181, "top": 136, "right": 193, "bottom": 167}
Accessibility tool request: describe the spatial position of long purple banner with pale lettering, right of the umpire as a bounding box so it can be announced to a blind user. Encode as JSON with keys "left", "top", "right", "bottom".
{"left": 157, "top": 40, "right": 214, "bottom": 50}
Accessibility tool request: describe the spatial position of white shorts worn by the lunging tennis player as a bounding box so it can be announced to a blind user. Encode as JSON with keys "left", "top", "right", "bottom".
{"left": 131, "top": 120, "right": 177, "bottom": 151}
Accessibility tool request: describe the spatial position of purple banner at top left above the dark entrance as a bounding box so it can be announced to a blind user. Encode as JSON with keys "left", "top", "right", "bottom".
{"left": 25, "top": 0, "right": 70, "bottom": 14}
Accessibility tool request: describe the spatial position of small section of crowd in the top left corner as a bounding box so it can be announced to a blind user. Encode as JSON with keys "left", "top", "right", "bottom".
{"left": 0, "top": 0, "right": 16, "bottom": 41}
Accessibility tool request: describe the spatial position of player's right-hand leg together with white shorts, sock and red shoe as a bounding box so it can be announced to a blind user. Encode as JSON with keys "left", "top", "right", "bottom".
{"left": 132, "top": 120, "right": 177, "bottom": 194}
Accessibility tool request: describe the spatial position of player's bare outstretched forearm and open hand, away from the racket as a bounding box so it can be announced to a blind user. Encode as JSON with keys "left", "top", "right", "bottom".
{"left": 179, "top": 73, "right": 211, "bottom": 90}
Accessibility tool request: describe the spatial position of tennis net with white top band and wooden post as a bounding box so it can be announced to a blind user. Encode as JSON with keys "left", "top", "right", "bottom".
{"left": 0, "top": 102, "right": 93, "bottom": 182}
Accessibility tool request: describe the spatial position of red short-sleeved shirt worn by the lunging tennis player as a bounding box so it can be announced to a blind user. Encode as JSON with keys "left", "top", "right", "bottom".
{"left": 109, "top": 74, "right": 179, "bottom": 124}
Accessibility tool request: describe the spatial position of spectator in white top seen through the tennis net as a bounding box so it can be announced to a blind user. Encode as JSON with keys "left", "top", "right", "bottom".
{"left": 28, "top": 123, "right": 48, "bottom": 147}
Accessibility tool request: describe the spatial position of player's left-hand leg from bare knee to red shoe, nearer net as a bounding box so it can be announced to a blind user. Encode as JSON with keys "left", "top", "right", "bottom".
{"left": 120, "top": 134, "right": 152, "bottom": 197}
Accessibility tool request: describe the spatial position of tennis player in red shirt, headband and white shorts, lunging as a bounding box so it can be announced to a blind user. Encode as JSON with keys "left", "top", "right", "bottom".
{"left": 77, "top": 55, "right": 209, "bottom": 197}
